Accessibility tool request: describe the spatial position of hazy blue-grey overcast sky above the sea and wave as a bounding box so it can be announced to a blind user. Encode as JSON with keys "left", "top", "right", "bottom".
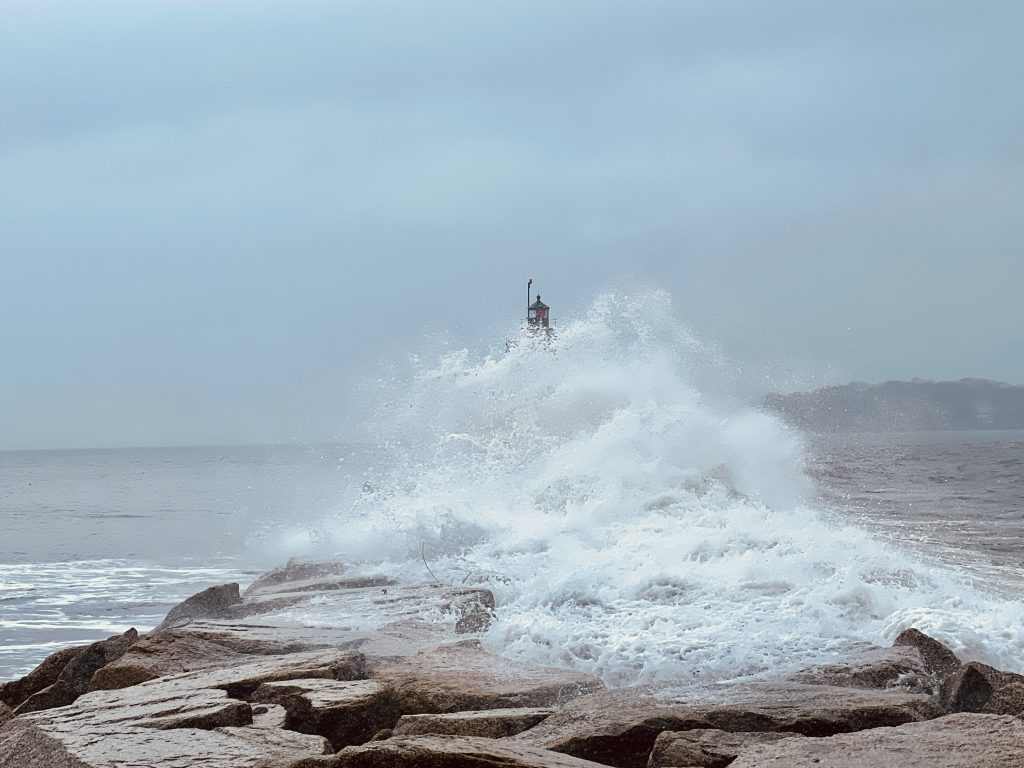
{"left": 0, "top": 0, "right": 1024, "bottom": 449}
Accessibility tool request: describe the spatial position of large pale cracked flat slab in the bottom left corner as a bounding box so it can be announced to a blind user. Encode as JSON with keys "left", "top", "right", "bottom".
{"left": 0, "top": 681, "right": 330, "bottom": 768}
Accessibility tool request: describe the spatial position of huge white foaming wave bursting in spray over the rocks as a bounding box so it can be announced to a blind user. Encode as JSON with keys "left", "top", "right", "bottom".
{"left": 272, "top": 292, "right": 1024, "bottom": 685}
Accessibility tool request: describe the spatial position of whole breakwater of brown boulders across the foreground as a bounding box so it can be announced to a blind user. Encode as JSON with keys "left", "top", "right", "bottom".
{"left": 0, "top": 563, "right": 1024, "bottom": 768}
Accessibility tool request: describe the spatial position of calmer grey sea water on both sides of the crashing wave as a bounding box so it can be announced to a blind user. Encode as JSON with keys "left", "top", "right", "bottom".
{"left": 0, "top": 431, "right": 1024, "bottom": 680}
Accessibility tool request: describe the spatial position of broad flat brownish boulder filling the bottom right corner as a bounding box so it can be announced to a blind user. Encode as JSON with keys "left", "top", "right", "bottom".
{"left": 731, "top": 714, "right": 1024, "bottom": 768}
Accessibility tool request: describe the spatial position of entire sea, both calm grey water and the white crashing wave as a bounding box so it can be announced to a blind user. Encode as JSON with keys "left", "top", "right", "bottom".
{"left": 0, "top": 296, "right": 1024, "bottom": 686}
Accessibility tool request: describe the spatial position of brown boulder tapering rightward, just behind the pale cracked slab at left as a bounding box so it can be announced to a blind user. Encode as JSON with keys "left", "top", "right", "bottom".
{"left": 90, "top": 630, "right": 317, "bottom": 690}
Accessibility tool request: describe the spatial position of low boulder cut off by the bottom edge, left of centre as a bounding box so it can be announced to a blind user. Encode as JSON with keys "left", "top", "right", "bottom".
{"left": 307, "top": 736, "right": 614, "bottom": 768}
